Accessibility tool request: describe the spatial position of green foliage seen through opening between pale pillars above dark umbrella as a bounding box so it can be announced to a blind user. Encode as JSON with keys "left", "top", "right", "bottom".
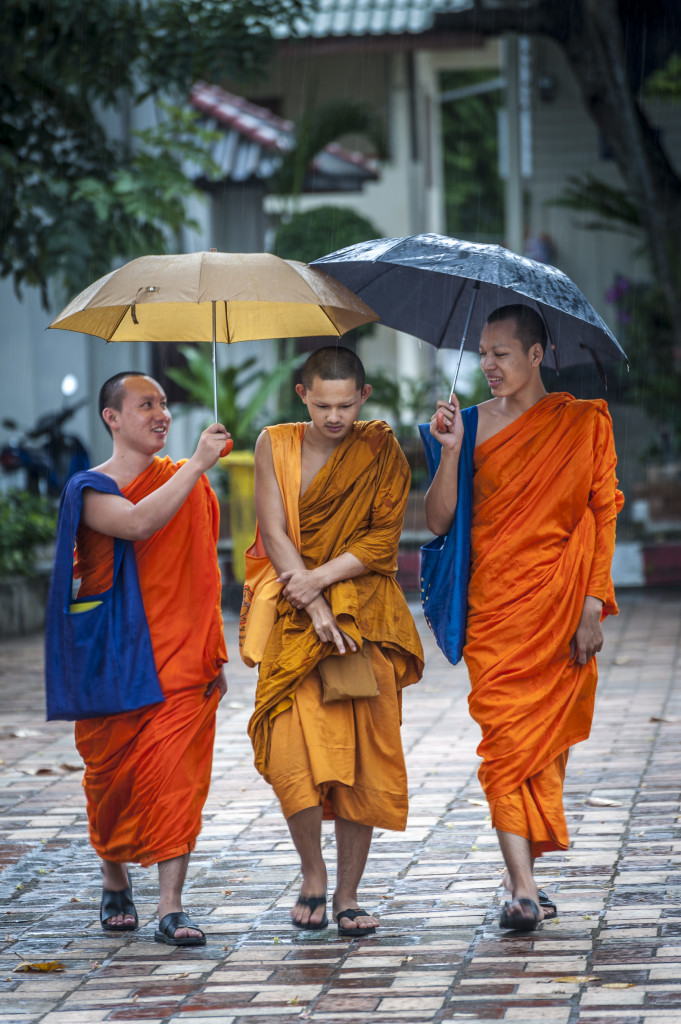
{"left": 440, "top": 71, "right": 504, "bottom": 241}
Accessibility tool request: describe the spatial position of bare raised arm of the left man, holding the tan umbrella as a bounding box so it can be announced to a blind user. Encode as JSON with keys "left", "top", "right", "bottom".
{"left": 81, "top": 423, "right": 229, "bottom": 541}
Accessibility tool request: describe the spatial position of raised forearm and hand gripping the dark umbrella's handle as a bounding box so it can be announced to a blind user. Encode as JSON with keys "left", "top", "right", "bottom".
{"left": 425, "top": 394, "right": 464, "bottom": 537}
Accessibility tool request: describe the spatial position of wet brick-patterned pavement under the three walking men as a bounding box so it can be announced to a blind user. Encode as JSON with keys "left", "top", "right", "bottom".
{"left": 0, "top": 591, "right": 681, "bottom": 1024}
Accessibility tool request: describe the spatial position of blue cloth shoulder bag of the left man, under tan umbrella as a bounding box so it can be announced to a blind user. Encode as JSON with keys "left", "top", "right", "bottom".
{"left": 45, "top": 471, "right": 164, "bottom": 722}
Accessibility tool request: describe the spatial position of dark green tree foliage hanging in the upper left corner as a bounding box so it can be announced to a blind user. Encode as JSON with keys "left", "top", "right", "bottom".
{"left": 0, "top": 0, "right": 310, "bottom": 300}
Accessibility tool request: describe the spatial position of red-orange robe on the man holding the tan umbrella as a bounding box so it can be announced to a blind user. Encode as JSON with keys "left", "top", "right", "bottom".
{"left": 74, "top": 458, "right": 227, "bottom": 866}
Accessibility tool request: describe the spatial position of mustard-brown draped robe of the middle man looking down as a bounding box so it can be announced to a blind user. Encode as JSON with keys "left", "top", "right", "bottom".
{"left": 249, "top": 420, "right": 423, "bottom": 828}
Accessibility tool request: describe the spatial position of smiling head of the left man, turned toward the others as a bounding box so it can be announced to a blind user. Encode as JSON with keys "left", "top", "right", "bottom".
{"left": 102, "top": 377, "right": 172, "bottom": 455}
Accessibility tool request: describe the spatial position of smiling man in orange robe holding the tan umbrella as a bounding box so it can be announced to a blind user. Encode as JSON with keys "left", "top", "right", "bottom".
{"left": 67, "top": 373, "right": 228, "bottom": 945}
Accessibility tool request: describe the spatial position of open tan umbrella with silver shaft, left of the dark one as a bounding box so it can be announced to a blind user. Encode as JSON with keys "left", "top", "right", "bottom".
{"left": 49, "top": 250, "right": 378, "bottom": 420}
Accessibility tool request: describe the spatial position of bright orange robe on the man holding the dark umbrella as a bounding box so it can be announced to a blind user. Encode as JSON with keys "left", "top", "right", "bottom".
{"left": 464, "top": 393, "right": 624, "bottom": 856}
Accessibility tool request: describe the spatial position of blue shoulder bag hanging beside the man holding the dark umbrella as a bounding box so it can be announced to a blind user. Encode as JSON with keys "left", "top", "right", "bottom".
{"left": 419, "top": 406, "right": 477, "bottom": 665}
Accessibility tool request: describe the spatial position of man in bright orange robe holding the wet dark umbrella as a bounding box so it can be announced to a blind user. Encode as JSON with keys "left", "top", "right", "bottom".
{"left": 426, "top": 304, "right": 624, "bottom": 931}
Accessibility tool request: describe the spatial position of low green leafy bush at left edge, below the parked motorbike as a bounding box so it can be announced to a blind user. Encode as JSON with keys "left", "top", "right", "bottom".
{"left": 0, "top": 490, "right": 56, "bottom": 577}
